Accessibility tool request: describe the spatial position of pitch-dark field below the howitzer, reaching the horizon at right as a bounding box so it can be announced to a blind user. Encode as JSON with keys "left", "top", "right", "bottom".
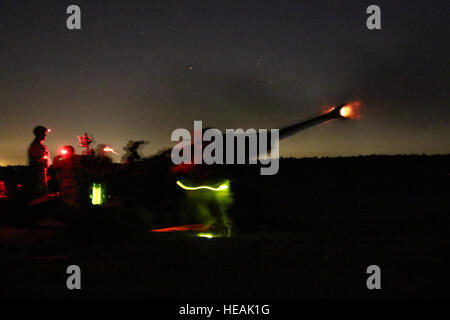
{"left": 0, "top": 156, "right": 450, "bottom": 301}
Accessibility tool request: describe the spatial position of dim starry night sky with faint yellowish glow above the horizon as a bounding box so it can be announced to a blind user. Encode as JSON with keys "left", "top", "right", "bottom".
{"left": 0, "top": 0, "right": 450, "bottom": 165}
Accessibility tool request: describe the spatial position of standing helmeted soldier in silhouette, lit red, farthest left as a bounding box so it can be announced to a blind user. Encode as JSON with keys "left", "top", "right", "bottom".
{"left": 28, "top": 126, "right": 50, "bottom": 198}
